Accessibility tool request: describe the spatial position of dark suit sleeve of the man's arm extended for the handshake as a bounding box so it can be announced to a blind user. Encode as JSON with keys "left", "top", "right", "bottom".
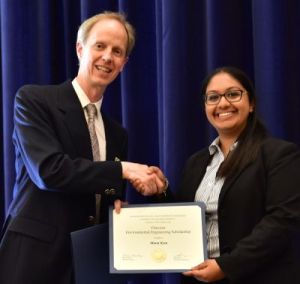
{"left": 13, "top": 87, "right": 127, "bottom": 193}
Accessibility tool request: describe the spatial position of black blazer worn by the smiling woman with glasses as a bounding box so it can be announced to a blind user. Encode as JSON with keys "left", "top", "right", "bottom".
{"left": 177, "top": 138, "right": 300, "bottom": 284}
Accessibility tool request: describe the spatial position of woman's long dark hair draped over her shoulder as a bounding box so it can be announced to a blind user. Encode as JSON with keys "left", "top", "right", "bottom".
{"left": 201, "top": 66, "right": 267, "bottom": 177}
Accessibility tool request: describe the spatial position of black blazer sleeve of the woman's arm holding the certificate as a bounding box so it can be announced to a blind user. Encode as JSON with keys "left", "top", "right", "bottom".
{"left": 216, "top": 140, "right": 300, "bottom": 282}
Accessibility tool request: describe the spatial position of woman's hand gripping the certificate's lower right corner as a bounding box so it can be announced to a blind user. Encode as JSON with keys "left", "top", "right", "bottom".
{"left": 183, "top": 259, "right": 225, "bottom": 283}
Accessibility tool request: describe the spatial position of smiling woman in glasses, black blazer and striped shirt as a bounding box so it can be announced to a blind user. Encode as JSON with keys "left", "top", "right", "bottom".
{"left": 177, "top": 67, "right": 300, "bottom": 284}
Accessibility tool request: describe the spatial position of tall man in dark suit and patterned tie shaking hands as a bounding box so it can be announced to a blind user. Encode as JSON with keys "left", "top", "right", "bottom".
{"left": 0, "top": 12, "right": 164, "bottom": 284}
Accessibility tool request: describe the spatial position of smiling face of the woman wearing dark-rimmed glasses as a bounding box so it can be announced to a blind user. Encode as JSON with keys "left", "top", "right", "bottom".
{"left": 205, "top": 73, "right": 254, "bottom": 139}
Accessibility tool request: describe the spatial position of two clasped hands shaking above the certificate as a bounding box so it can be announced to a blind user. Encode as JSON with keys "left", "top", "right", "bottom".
{"left": 121, "top": 162, "right": 168, "bottom": 196}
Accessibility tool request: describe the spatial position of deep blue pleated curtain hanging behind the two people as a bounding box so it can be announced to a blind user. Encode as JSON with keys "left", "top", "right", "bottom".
{"left": 0, "top": 0, "right": 300, "bottom": 284}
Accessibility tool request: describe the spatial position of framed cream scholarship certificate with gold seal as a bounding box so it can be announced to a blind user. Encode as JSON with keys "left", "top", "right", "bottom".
{"left": 109, "top": 202, "right": 207, "bottom": 273}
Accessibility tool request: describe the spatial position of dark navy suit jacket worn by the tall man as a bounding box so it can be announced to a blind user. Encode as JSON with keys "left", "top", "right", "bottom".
{"left": 0, "top": 81, "right": 127, "bottom": 284}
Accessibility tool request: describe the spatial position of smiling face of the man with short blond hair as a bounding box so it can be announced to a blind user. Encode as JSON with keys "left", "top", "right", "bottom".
{"left": 76, "top": 19, "right": 128, "bottom": 88}
